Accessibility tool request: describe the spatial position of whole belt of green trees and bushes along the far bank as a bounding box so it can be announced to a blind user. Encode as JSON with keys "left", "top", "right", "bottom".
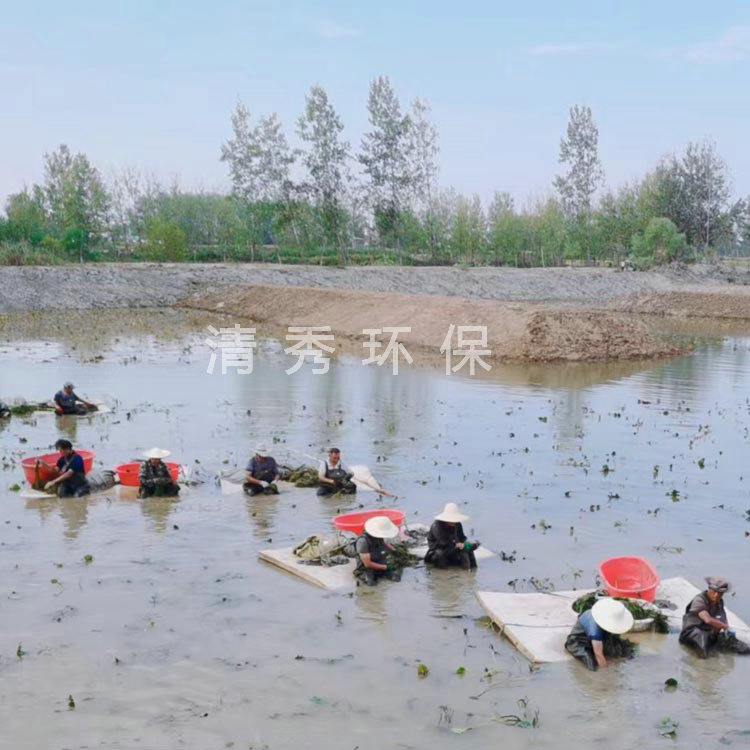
{"left": 0, "top": 78, "right": 750, "bottom": 267}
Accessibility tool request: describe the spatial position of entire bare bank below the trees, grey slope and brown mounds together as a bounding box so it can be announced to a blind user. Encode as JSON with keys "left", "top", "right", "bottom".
{"left": 0, "top": 263, "right": 750, "bottom": 362}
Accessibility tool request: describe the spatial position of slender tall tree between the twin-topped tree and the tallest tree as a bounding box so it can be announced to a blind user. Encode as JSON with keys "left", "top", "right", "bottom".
{"left": 297, "top": 86, "right": 349, "bottom": 248}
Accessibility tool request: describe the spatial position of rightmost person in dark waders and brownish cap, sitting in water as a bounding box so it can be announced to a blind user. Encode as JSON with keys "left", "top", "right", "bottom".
{"left": 680, "top": 576, "right": 750, "bottom": 659}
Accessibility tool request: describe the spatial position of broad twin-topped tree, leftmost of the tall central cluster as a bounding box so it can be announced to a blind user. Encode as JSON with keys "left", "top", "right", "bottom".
{"left": 221, "top": 102, "right": 294, "bottom": 257}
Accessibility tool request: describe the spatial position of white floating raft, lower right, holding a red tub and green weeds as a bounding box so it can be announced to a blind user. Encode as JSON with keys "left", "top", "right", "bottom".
{"left": 477, "top": 578, "right": 750, "bottom": 663}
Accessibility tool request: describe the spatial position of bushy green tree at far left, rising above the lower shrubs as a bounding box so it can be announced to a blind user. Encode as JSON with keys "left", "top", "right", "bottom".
{"left": 42, "top": 144, "right": 110, "bottom": 250}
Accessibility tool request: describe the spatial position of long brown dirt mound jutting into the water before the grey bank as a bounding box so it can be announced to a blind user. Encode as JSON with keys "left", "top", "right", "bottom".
{"left": 181, "top": 286, "right": 680, "bottom": 362}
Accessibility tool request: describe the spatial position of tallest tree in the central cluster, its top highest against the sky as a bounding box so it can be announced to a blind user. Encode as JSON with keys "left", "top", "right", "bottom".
{"left": 358, "top": 76, "right": 412, "bottom": 247}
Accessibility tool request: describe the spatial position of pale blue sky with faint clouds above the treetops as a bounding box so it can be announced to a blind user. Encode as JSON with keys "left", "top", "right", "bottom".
{"left": 0, "top": 0, "right": 750, "bottom": 203}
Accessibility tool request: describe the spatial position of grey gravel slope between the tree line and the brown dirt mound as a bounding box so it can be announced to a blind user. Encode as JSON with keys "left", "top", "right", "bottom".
{"left": 0, "top": 263, "right": 744, "bottom": 312}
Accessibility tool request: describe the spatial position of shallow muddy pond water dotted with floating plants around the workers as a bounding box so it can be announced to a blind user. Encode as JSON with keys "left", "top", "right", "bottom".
{"left": 0, "top": 311, "right": 750, "bottom": 750}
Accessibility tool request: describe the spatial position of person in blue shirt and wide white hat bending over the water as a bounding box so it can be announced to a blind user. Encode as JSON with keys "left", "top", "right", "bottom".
{"left": 565, "top": 597, "right": 634, "bottom": 672}
